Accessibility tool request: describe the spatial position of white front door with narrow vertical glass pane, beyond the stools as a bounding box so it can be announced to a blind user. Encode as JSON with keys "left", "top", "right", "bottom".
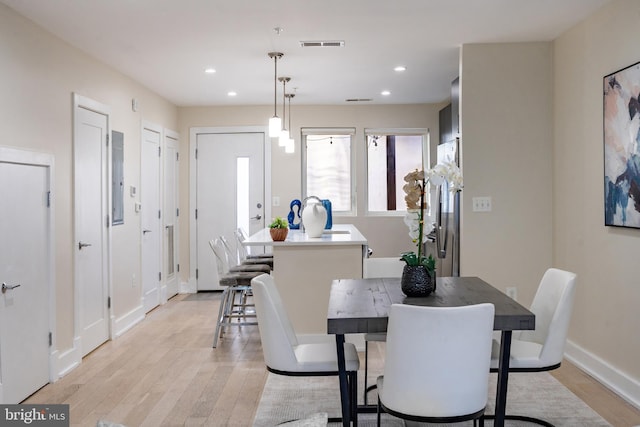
{"left": 196, "top": 133, "right": 265, "bottom": 291}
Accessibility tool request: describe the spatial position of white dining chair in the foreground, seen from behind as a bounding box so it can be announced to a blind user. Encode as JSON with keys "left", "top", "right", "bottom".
{"left": 377, "top": 303, "right": 495, "bottom": 426}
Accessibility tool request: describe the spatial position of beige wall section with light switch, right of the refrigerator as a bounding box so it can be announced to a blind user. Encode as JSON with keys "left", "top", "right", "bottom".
{"left": 460, "top": 42, "right": 553, "bottom": 305}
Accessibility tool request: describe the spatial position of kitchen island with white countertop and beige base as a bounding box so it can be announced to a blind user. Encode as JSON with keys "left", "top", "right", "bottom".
{"left": 243, "top": 224, "right": 367, "bottom": 335}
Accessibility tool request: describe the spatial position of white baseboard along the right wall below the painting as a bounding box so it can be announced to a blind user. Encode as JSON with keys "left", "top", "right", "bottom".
{"left": 565, "top": 341, "right": 640, "bottom": 409}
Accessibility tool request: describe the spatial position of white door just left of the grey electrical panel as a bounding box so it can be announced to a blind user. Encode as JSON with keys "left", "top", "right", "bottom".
{"left": 73, "top": 100, "right": 109, "bottom": 356}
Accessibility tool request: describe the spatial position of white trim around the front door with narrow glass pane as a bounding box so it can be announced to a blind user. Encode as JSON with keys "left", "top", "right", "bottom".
{"left": 189, "top": 126, "right": 271, "bottom": 293}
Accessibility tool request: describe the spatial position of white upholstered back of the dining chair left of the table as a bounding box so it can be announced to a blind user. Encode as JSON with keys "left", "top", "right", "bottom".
{"left": 251, "top": 274, "right": 299, "bottom": 371}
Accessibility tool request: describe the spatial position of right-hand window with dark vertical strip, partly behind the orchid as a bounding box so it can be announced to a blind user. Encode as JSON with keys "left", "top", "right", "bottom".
{"left": 365, "top": 129, "right": 429, "bottom": 214}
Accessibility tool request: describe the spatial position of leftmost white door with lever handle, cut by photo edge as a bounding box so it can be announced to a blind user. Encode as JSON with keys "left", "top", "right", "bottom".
{"left": 0, "top": 152, "right": 52, "bottom": 404}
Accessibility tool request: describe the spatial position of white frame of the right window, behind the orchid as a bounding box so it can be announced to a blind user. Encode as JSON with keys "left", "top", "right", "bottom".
{"left": 363, "top": 128, "right": 431, "bottom": 217}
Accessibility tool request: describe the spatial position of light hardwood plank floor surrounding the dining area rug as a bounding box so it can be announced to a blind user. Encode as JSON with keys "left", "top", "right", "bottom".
{"left": 25, "top": 293, "right": 640, "bottom": 427}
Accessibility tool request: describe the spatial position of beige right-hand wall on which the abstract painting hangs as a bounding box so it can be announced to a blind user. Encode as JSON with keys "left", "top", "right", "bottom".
{"left": 553, "top": 0, "right": 640, "bottom": 406}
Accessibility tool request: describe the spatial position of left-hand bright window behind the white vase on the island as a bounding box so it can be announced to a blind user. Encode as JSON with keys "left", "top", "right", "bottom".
{"left": 302, "top": 128, "right": 355, "bottom": 213}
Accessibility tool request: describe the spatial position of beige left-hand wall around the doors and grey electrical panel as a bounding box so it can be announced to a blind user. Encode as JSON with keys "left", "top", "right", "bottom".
{"left": 0, "top": 4, "right": 177, "bottom": 369}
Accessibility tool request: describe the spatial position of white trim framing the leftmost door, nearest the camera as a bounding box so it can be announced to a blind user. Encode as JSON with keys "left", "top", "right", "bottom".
{"left": 0, "top": 146, "right": 57, "bottom": 392}
